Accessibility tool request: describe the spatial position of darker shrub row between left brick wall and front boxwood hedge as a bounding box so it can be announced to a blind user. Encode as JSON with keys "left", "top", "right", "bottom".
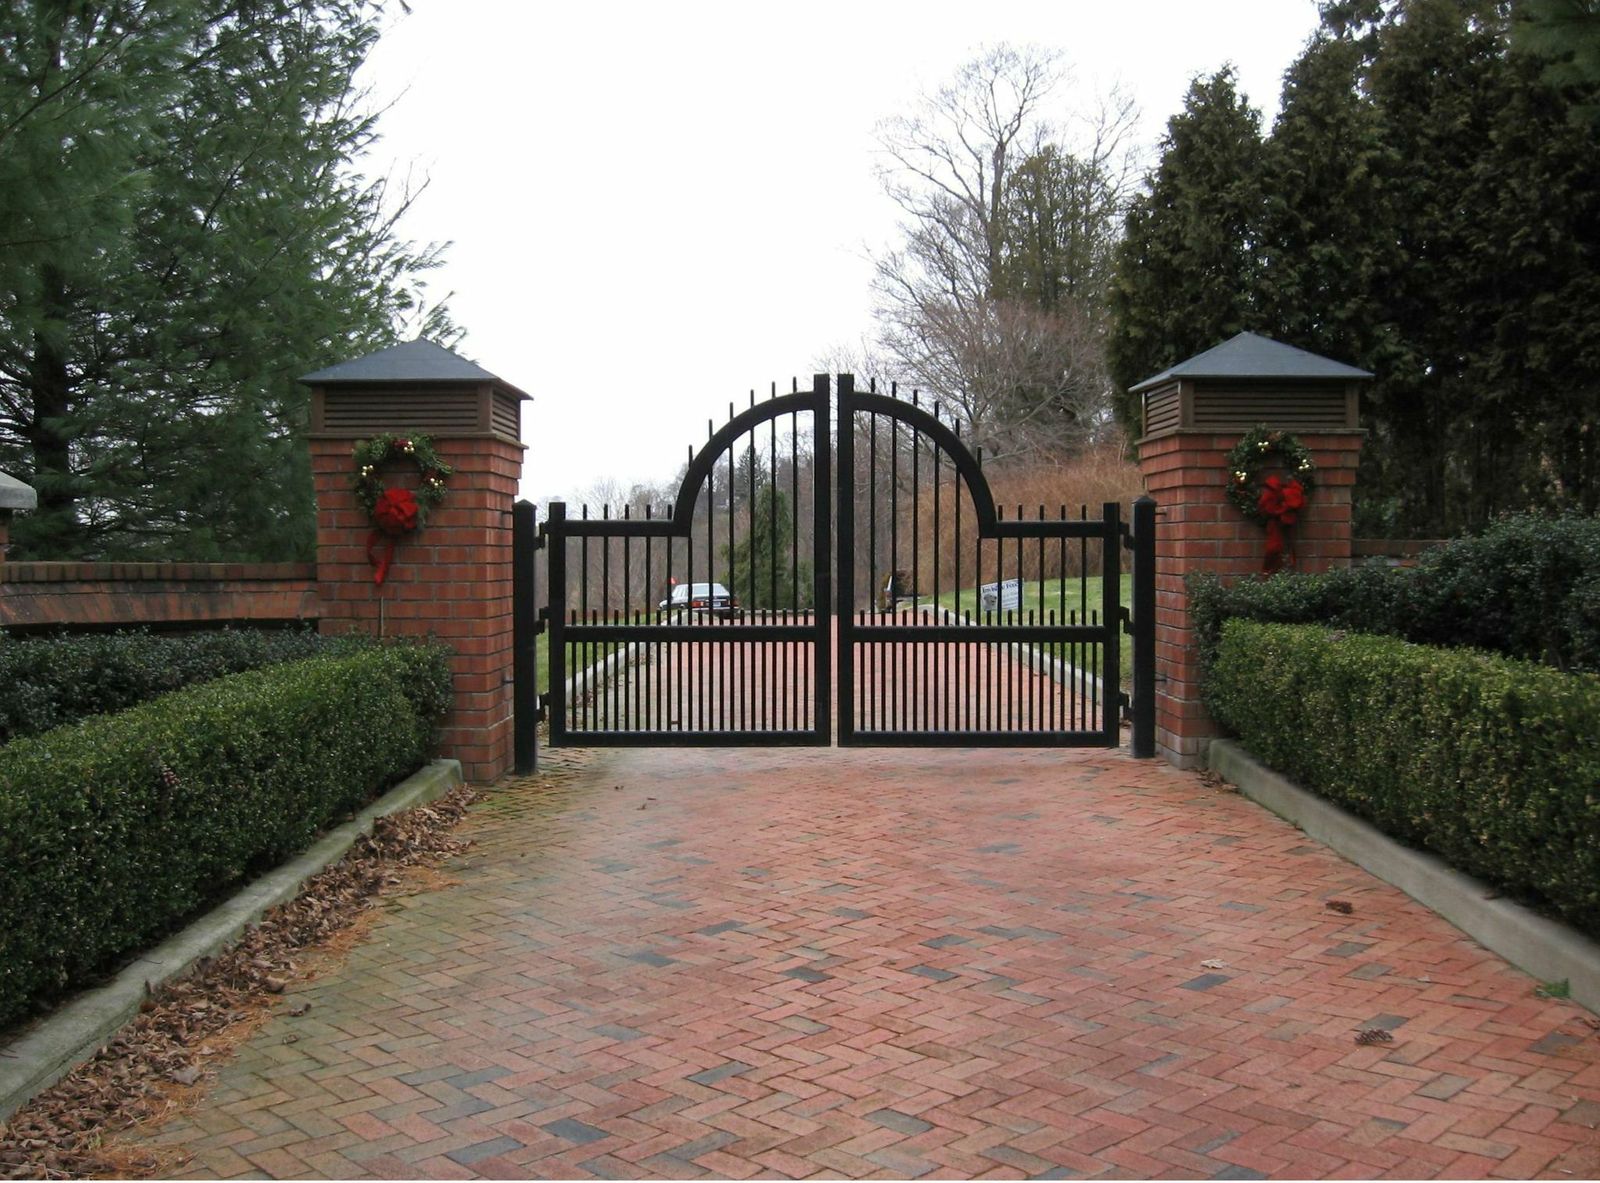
{"left": 0, "top": 629, "right": 342, "bottom": 743}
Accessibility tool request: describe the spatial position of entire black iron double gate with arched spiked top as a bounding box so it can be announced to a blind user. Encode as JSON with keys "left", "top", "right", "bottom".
{"left": 541, "top": 375, "right": 1155, "bottom": 756}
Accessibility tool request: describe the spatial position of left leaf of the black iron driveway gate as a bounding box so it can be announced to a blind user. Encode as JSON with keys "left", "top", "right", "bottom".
{"left": 544, "top": 376, "right": 834, "bottom": 746}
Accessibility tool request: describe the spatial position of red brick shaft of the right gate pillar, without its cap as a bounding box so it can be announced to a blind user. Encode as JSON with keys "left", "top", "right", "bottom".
{"left": 1139, "top": 429, "right": 1365, "bottom": 768}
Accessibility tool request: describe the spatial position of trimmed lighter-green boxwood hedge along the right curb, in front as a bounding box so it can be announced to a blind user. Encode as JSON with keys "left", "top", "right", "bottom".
{"left": 1203, "top": 620, "right": 1600, "bottom": 936}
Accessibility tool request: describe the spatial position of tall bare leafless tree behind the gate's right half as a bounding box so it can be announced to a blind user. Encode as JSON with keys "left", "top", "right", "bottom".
{"left": 875, "top": 45, "right": 1133, "bottom": 458}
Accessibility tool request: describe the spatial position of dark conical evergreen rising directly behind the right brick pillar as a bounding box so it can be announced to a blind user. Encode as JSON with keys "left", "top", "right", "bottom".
{"left": 1107, "top": 69, "right": 1262, "bottom": 434}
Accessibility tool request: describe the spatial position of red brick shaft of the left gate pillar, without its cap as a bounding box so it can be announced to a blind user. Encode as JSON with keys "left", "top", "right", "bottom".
{"left": 310, "top": 432, "right": 523, "bottom": 783}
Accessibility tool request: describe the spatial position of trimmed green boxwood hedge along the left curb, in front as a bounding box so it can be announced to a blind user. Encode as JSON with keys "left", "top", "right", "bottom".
{"left": 0, "top": 644, "right": 451, "bottom": 1026}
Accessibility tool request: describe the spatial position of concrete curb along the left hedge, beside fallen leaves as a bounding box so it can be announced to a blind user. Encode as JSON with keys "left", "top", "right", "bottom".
{"left": 0, "top": 760, "right": 462, "bottom": 1122}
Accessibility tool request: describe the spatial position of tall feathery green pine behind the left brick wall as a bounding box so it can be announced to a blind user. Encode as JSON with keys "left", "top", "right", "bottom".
{"left": 0, "top": 0, "right": 451, "bottom": 559}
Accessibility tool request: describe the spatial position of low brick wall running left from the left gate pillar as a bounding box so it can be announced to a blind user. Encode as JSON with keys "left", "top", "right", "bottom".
{"left": 0, "top": 562, "right": 322, "bottom": 628}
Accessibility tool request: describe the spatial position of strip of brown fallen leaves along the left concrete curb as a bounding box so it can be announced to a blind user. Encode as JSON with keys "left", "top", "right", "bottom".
{"left": 0, "top": 786, "right": 477, "bottom": 1178}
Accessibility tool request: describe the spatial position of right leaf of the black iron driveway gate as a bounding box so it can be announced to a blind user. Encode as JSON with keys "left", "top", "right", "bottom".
{"left": 838, "top": 375, "right": 1125, "bottom": 746}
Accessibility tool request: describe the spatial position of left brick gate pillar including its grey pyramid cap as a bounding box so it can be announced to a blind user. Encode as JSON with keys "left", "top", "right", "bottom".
{"left": 302, "top": 341, "right": 526, "bottom": 784}
